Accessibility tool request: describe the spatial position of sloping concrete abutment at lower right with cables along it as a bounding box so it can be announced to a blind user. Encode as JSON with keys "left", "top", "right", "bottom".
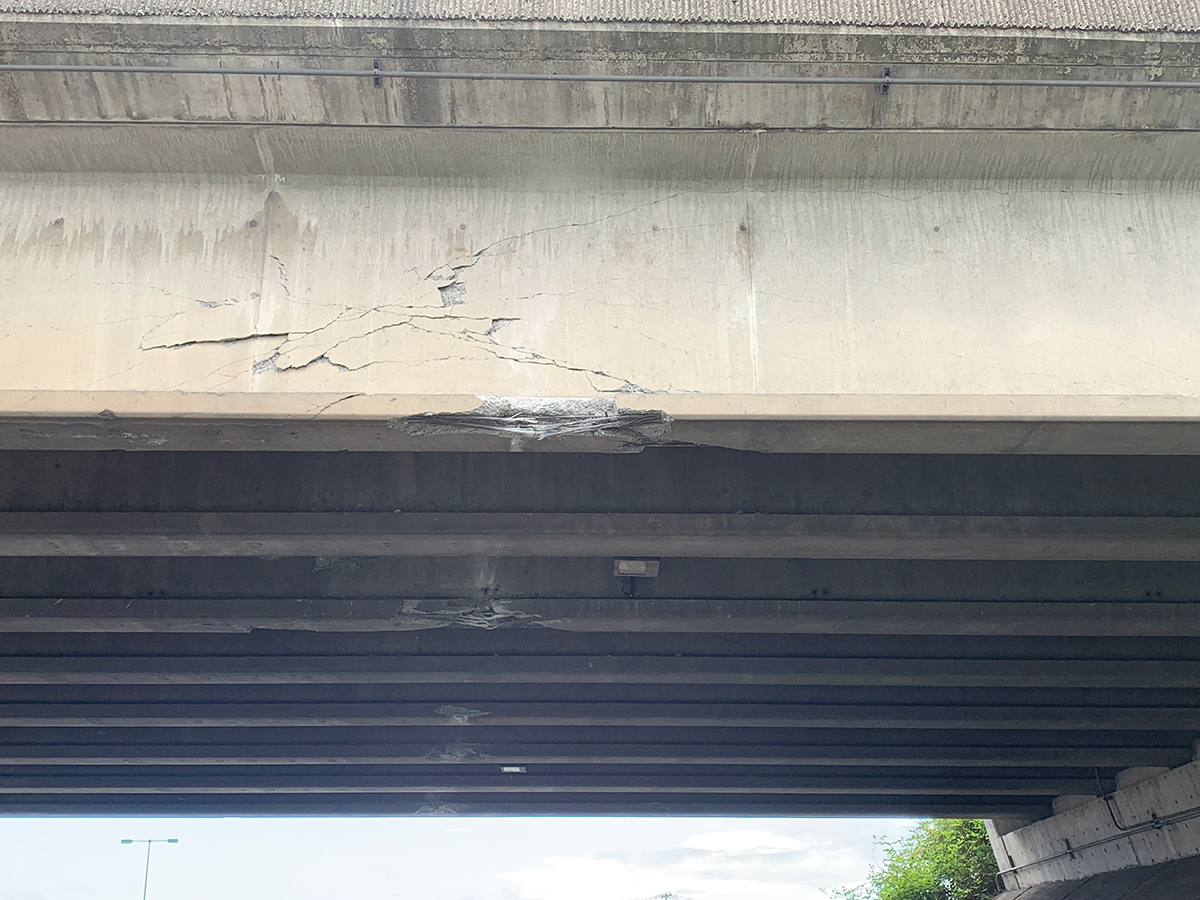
{"left": 990, "top": 762, "right": 1200, "bottom": 898}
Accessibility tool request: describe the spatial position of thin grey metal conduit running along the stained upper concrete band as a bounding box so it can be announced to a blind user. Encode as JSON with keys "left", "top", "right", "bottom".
{"left": 0, "top": 62, "right": 1200, "bottom": 90}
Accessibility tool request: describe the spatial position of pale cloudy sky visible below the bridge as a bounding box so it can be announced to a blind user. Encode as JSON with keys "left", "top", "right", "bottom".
{"left": 0, "top": 817, "right": 914, "bottom": 900}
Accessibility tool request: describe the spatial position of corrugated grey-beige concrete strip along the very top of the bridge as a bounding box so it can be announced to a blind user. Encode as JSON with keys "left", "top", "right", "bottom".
{"left": 0, "top": 0, "right": 1200, "bottom": 31}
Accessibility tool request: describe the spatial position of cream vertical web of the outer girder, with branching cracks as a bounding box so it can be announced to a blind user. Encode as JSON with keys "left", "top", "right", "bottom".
{"left": 0, "top": 169, "right": 1200, "bottom": 405}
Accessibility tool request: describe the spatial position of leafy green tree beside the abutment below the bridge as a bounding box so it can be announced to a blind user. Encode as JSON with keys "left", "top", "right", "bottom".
{"left": 836, "top": 818, "right": 997, "bottom": 900}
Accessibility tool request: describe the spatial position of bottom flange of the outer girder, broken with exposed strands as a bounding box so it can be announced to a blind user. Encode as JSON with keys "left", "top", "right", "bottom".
{"left": 0, "top": 391, "right": 1200, "bottom": 455}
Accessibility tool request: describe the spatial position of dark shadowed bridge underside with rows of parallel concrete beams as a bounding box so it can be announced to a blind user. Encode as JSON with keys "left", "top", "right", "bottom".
{"left": 0, "top": 448, "right": 1200, "bottom": 820}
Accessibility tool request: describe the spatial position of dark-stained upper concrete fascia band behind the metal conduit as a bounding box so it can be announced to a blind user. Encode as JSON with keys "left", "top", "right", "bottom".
{"left": 0, "top": 14, "right": 1200, "bottom": 131}
